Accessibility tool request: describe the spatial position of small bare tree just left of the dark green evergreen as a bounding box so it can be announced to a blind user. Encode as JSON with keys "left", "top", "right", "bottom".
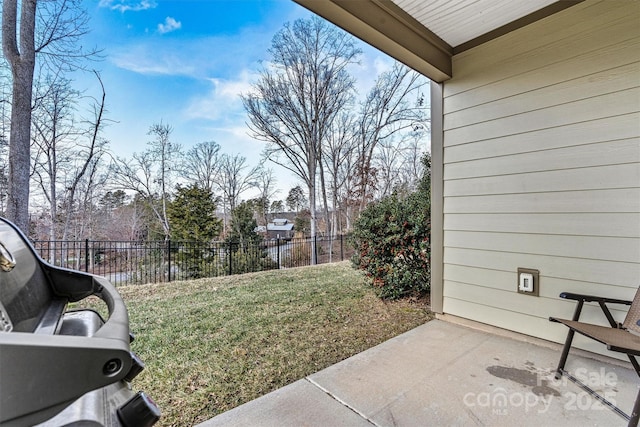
{"left": 113, "top": 122, "right": 182, "bottom": 239}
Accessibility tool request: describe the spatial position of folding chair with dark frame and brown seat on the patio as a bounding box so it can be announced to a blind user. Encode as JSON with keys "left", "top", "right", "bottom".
{"left": 549, "top": 288, "right": 640, "bottom": 427}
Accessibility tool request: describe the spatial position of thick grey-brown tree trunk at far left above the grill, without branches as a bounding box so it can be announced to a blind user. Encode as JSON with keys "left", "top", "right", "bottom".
{"left": 2, "top": 0, "right": 36, "bottom": 234}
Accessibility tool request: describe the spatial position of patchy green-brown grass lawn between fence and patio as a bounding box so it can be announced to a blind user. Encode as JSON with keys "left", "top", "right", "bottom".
{"left": 102, "top": 262, "right": 431, "bottom": 426}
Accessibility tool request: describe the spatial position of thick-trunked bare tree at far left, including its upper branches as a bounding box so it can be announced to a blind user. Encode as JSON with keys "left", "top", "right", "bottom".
{"left": 2, "top": 0, "right": 96, "bottom": 232}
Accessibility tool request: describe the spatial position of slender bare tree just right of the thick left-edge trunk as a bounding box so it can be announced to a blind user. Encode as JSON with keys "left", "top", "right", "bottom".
{"left": 32, "top": 73, "right": 107, "bottom": 261}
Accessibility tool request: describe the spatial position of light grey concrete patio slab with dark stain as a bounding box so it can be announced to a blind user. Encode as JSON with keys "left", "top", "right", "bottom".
{"left": 200, "top": 319, "right": 640, "bottom": 427}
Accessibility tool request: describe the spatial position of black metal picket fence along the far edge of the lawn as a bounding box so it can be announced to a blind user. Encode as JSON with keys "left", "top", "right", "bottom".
{"left": 32, "top": 235, "right": 353, "bottom": 285}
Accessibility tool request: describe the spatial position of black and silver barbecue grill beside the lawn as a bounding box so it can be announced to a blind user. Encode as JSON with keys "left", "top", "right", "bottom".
{"left": 0, "top": 218, "right": 160, "bottom": 427}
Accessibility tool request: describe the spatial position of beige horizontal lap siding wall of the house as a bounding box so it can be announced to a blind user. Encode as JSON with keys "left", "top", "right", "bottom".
{"left": 443, "top": 1, "right": 640, "bottom": 349}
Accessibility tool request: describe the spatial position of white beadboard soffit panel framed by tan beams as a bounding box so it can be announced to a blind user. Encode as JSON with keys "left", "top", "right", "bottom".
{"left": 391, "top": 0, "right": 557, "bottom": 47}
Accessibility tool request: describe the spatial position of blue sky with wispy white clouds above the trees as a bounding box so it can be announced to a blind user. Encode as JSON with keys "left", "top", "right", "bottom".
{"left": 80, "top": 0, "right": 391, "bottom": 199}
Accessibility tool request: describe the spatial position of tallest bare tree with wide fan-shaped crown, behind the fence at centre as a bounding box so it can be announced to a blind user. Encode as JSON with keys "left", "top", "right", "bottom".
{"left": 242, "top": 17, "right": 361, "bottom": 263}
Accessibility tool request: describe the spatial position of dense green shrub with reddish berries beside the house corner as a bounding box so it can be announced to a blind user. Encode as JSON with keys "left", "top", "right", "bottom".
{"left": 351, "top": 156, "right": 431, "bottom": 299}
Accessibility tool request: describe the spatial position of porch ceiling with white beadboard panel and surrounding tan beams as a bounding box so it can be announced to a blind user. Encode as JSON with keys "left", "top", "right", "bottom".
{"left": 294, "top": 0, "right": 582, "bottom": 82}
